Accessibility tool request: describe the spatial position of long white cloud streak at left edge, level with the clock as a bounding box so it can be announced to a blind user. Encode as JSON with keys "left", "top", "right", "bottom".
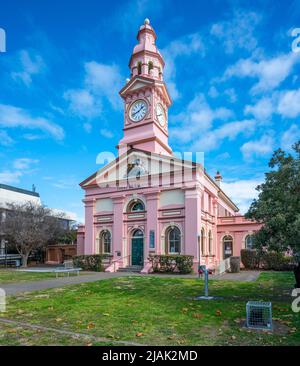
{"left": 0, "top": 104, "right": 64, "bottom": 140}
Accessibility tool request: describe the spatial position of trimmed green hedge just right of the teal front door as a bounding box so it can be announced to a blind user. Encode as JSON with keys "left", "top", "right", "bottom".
{"left": 149, "top": 255, "right": 194, "bottom": 274}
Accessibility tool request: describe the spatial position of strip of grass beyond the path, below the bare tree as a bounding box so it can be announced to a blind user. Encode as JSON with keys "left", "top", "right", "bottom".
{"left": 0, "top": 269, "right": 94, "bottom": 287}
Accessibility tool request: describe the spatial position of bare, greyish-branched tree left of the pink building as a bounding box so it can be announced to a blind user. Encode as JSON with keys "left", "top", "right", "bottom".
{"left": 0, "top": 202, "right": 65, "bottom": 267}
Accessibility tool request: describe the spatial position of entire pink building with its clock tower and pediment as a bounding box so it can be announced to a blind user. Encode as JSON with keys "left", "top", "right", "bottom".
{"left": 78, "top": 19, "right": 260, "bottom": 273}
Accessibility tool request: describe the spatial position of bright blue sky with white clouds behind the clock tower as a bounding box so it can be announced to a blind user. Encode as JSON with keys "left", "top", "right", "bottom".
{"left": 0, "top": 0, "right": 300, "bottom": 220}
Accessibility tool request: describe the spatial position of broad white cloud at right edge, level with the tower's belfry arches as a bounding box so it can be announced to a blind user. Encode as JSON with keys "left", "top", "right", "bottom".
{"left": 223, "top": 52, "right": 300, "bottom": 94}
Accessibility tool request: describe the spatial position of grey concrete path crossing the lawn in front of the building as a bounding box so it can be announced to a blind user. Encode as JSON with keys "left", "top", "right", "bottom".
{"left": 0, "top": 271, "right": 260, "bottom": 295}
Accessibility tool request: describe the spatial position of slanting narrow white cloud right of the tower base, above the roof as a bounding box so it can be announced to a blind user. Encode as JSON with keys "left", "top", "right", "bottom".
{"left": 191, "top": 119, "right": 256, "bottom": 151}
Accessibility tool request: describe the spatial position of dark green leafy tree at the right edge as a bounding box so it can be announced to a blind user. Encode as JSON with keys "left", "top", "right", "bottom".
{"left": 245, "top": 141, "right": 300, "bottom": 288}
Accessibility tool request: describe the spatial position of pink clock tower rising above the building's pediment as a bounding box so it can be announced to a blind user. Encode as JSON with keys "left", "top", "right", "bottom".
{"left": 118, "top": 19, "right": 172, "bottom": 156}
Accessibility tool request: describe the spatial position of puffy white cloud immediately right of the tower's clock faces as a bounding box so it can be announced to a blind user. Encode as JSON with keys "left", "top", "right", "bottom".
{"left": 171, "top": 94, "right": 233, "bottom": 143}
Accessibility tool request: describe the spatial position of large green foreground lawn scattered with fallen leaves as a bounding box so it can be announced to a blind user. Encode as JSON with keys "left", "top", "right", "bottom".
{"left": 0, "top": 272, "right": 300, "bottom": 346}
